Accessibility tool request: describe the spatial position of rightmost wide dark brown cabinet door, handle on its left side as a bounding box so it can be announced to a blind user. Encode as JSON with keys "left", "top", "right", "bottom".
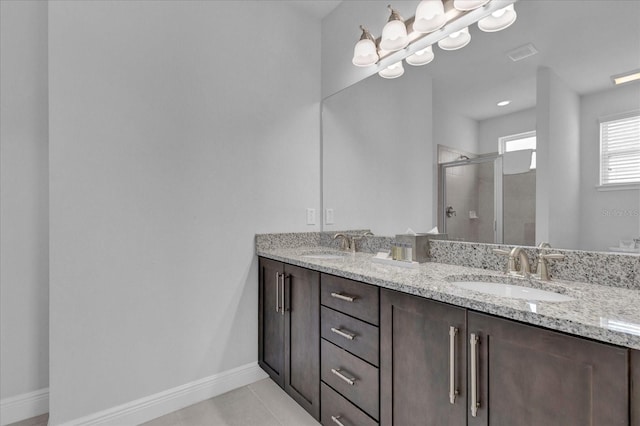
{"left": 468, "top": 312, "right": 629, "bottom": 426}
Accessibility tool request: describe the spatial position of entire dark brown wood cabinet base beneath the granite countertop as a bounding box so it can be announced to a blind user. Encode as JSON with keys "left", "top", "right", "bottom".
{"left": 258, "top": 258, "right": 640, "bottom": 426}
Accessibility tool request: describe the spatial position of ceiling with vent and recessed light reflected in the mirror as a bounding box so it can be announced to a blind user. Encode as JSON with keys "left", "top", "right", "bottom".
{"left": 420, "top": 0, "right": 640, "bottom": 120}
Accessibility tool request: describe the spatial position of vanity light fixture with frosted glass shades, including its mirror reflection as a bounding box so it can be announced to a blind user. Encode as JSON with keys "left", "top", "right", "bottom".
{"left": 352, "top": 0, "right": 518, "bottom": 78}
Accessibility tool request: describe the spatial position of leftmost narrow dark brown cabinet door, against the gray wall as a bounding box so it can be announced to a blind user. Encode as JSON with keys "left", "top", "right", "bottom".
{"left": 258, "top": 258, "right": 284, "bottom": 387}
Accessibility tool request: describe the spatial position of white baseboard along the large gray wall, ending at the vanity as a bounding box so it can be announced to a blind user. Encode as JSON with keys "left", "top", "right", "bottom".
{"left": 49, "top": 362, "right": 268, "bottom": 426}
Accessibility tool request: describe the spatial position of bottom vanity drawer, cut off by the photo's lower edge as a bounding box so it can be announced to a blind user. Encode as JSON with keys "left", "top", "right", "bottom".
{"left": 320, "top": 383, "right": 378, "bottom": 426}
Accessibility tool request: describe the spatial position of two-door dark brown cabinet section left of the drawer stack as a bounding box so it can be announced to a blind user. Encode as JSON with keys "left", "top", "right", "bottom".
{"left": 258, "top": 258, "right": 320, "bottom": 419}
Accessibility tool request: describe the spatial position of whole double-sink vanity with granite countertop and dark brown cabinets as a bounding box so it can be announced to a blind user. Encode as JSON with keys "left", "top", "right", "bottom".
{"left": 256, "top": 233, "right": 640, "bottom": 426}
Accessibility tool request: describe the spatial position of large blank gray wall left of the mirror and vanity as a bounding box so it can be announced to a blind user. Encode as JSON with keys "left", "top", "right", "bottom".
{"left": 49, "top": 1, "right": 320, "bottom": 425}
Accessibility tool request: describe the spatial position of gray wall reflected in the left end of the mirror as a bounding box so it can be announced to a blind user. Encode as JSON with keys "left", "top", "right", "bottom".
{"left": 322, "top": 66, "right": 436, "bottom": 235}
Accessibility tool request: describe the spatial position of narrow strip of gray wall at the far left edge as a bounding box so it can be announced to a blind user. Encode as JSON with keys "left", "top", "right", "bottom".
{"left": 0, "top": 1, "right": 49, "bottom": 408}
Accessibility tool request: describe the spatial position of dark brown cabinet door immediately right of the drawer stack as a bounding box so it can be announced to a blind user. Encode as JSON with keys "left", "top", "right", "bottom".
{"left": 380, "top": 289, "right": 467, "bottom": 426}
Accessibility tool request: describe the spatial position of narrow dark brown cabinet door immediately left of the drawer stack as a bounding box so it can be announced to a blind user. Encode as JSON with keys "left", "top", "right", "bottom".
{"left": 284, "top": 265, "right": 320, "bottom": 419}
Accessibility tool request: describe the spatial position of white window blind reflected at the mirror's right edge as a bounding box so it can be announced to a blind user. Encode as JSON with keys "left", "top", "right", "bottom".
{"left": 600, "top": 111, "right": 640, "bottom": 186}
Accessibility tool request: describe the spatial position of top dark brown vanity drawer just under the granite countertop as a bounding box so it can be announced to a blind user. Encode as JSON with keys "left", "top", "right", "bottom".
{"left": 320, "top": 274, "right": 380, "bottom": 325}
